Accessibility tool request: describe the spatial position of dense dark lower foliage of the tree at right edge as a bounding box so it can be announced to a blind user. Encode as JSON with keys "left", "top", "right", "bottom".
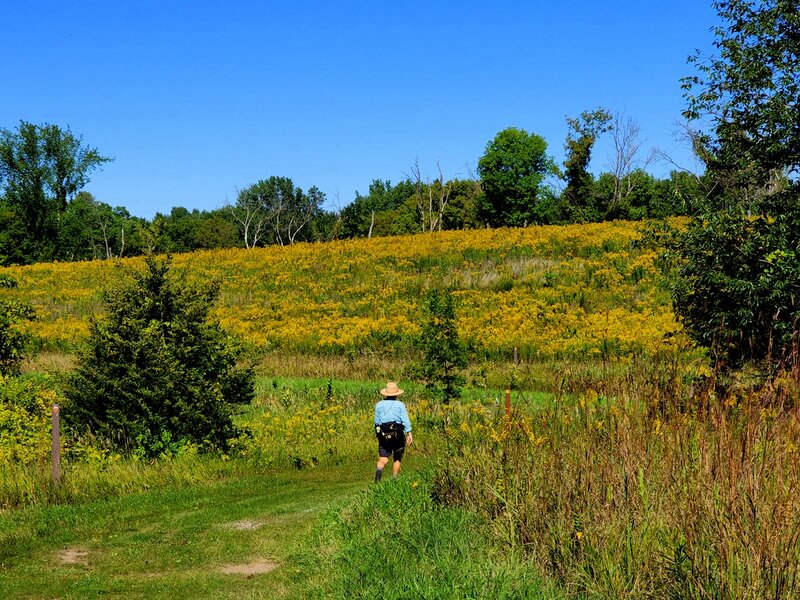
{"left": 672, "top": 201, "right": 800, "bottom": 367}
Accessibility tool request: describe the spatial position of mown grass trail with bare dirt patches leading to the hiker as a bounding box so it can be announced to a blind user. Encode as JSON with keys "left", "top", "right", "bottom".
{"left": 0, "top": 463, "right": 384, "bottom": 600}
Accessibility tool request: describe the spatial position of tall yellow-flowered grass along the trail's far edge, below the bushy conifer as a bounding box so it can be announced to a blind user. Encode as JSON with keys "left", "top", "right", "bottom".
{"left": 0, "top": 377, "right": 456, "bottom": 509}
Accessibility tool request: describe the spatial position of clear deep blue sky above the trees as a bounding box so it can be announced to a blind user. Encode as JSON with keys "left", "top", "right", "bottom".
{"left": 0, "top": 0, "right": 715, "bottom": 219}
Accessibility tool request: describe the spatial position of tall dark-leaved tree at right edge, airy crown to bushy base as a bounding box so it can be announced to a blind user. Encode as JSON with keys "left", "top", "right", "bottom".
{"left": 674, "top": 0, "right": 800, "bottom": 366}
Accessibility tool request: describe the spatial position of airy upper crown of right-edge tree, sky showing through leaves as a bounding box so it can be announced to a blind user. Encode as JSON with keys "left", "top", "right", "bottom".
{"left": 683, "top": 0, "right": 800, "bottom": 192}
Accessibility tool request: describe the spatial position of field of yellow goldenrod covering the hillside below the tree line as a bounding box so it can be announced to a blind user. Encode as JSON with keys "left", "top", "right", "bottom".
{"left": 0, "top": 222, "right": 678, "bottom": 358}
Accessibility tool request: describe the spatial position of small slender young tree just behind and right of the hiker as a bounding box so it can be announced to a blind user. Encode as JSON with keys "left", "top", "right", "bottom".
{"left": 420, "top": 289, "right": 467, "bottom": 403}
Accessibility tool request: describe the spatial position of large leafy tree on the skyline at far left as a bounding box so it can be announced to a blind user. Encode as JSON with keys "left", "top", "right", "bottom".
{"left": 0, "top": 121, "right": 111, "bottom": 261}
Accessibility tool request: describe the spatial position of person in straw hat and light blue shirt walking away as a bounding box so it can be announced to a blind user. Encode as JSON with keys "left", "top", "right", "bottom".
{"left": 375, "top": 381, "right": 413, "bottom": 483}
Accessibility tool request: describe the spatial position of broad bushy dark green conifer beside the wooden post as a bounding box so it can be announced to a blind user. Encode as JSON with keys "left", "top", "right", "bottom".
{"left": 64, "top": 256, "right": 253, "bottom": 456}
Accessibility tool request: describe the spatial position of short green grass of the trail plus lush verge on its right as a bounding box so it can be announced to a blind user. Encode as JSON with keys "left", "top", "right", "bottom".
{"left": 0, "top": 454, "right": 562, "bottom": 600}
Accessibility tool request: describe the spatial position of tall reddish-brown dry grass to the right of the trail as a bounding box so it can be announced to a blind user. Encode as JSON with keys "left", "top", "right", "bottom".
{"left": 433, "top": 354, "right": 800, "bottom": 599}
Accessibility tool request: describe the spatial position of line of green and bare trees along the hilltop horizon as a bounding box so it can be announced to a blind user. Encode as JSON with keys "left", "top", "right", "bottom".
{"left": 0, "top": 109, "right": 710, "bottom": 265}
